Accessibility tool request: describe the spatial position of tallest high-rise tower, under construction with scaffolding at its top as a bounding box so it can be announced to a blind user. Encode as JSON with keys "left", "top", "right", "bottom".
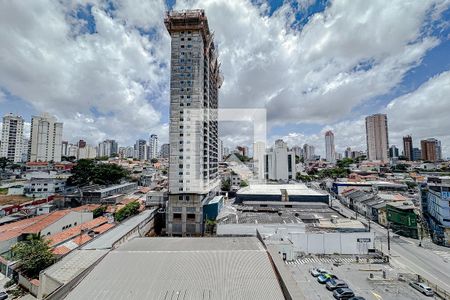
{"left": 164, "top": 10, "right": 222, "bottom": 236}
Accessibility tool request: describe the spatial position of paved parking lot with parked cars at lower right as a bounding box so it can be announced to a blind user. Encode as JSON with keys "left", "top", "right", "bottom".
{"left": 287, "top": 263, "right": 438, "bottom": 300}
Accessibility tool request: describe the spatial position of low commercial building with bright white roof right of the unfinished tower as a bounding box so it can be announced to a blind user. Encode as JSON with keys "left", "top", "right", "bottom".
{"left": 235, "top": 183, "right": 329, "bottom": 205}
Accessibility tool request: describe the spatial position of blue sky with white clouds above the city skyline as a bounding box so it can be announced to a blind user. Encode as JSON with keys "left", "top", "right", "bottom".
{"left": 0, "top": 0, "right": 450, "bottom": 157}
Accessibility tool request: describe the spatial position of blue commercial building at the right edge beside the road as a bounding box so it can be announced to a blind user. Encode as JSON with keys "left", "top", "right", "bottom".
{"left": 421, "top": 177, "right": 450, "bottom": 247}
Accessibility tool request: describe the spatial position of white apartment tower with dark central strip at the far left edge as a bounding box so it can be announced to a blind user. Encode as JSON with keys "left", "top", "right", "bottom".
{"left": 0, "top": 114, "right": 23, "bottom": 162}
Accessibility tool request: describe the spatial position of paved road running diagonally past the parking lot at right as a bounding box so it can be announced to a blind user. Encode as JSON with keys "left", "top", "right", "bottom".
{"left": 333, "top": 200, "right": 450, "bottom": 293}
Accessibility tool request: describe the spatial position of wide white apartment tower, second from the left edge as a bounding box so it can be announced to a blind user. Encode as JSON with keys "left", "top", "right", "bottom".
{"left": 29, "top": 113, "right": 63, "bottom": 162}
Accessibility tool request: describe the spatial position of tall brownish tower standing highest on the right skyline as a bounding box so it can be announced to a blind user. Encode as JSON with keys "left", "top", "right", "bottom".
{"left": 366, "top": 114, "right": 389, "bottom": 162}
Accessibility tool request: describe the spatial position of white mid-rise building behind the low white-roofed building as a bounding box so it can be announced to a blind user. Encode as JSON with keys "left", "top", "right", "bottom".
{"left": 264, "top": 140, "right": 296, "bottom": 181}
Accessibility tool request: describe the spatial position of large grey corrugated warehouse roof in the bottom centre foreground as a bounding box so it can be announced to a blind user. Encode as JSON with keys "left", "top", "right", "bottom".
{"left": 65, "top": 237, "right": 285, "bottom": 300}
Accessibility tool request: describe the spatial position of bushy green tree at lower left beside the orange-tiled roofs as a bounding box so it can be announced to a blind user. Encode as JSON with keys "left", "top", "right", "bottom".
{"left": 11, "top": 234, "right": 55, "bottom": 278}
